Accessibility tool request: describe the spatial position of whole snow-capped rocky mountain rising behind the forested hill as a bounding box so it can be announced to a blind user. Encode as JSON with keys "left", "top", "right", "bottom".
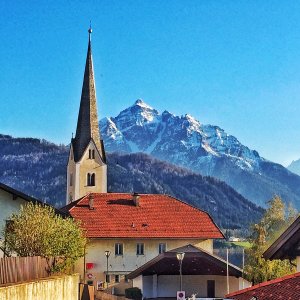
{"left": 100, "top": 99, "right": 300, "bottom": 206}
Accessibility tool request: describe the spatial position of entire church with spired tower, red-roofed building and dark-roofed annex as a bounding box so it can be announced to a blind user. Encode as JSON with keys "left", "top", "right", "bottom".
{"left": 62, "top": 28, "right": 248, "bottom": 298}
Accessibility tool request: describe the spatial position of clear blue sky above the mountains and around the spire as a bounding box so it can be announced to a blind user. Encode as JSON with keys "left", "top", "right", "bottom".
{"left": 0, "top": 0, "right": 300, "bottom": 165}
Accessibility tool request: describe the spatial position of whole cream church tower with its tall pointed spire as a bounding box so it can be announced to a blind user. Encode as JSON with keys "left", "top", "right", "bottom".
{"left": 66, "top": 28, "right": 107, "bottom": 204}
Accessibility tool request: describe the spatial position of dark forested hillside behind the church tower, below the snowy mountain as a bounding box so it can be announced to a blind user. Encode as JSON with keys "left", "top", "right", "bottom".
{"left": 0, "top": 135, "right": 263, "bottom": 228}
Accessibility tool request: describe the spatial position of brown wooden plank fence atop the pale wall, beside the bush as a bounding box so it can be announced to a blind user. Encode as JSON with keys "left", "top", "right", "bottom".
{"left": 0, "top": 256, "right": 49, "bottom": 285}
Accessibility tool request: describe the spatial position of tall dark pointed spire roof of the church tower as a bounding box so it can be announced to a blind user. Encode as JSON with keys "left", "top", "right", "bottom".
{"left": 72, "top": 29, "right": 104, "bottom": 162}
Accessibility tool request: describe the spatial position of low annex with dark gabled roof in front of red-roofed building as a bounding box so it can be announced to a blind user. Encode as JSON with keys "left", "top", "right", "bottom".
{"left": 128, "top": 244, "right": 250, "bottom": 299}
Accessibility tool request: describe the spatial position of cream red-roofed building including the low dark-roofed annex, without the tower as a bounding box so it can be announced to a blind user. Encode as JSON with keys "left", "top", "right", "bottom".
{"left": 64, "top": 193, "right": 251, "bottom": 298}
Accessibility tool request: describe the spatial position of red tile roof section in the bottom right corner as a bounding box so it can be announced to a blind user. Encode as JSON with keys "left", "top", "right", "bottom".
{"left": 226, "top": 272, "right": 300, "bottom": 300}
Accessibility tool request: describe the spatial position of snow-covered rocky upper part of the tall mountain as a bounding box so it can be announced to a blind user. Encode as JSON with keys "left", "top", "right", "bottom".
{"left": 100, "top": 99, "right": 262, "bottom": 170}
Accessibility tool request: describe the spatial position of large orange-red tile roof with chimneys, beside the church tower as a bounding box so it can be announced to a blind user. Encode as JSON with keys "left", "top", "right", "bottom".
{"left": 64, "top": 193, "right": 224, "bottom": 239}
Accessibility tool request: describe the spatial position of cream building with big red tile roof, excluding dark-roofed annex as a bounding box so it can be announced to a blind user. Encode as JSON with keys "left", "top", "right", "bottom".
{"left": 63, "top": 193, "right": 224, "bottom": 293}
